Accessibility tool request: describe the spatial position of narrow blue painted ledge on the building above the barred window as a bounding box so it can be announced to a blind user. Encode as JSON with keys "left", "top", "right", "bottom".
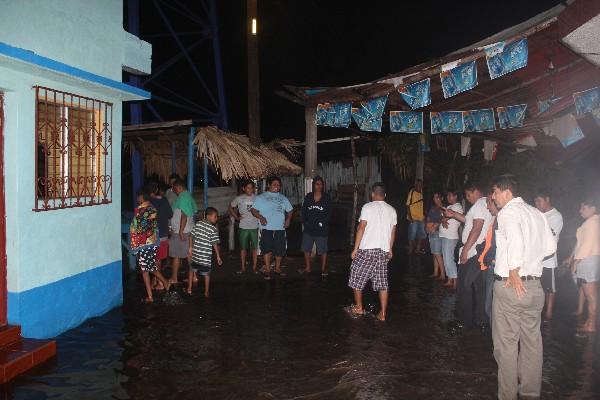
{"left": 0, "top": 42, "right": 151, "bottom": 99}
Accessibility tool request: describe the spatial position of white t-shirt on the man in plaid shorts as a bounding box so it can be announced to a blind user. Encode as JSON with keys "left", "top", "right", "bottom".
{"left": 359, "top": 201, "right": 397, "bottom": 252}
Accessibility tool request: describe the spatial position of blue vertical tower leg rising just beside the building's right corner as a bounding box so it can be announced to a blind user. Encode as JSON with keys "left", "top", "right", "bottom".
{"left": 127, "top": 0, "right": 144, "bottom": 208}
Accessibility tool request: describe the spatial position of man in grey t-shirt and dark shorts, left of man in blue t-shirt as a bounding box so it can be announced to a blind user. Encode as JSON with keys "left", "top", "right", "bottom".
{"left": 229, "top": 180, "right": 258, "bottom": 274}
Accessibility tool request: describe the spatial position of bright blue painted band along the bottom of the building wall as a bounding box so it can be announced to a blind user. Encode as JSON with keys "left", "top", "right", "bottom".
{"left": 8, "top": 260, "right": 123, "bottom": 339}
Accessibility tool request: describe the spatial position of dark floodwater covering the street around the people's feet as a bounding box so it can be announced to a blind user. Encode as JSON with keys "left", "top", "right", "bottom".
{"left": 2, "top": 253, "right": 600, "bottom": 400}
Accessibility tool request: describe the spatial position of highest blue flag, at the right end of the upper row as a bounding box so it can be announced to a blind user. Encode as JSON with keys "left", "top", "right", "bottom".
{"left": 485, "top": 39, "right": 528, "bottom": 79}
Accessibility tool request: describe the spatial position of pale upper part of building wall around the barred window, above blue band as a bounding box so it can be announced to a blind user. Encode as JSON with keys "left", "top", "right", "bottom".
{"left": 0, "top": 66, "right": 121, "bottom": 292}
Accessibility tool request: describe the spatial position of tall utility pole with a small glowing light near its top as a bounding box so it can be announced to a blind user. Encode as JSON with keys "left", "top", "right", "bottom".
{"left": 246, "top": 0, "right": 261, "bottom": 145}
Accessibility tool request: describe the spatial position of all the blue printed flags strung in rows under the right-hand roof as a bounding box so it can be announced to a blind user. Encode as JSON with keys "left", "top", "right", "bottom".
{"left": 316, "top": 38, "right": 600, "bottom": 152}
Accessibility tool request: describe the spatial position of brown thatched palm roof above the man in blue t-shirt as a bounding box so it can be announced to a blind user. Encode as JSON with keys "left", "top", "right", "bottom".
{"left": 194, "top": 126, "right": 302, "bottom": 181}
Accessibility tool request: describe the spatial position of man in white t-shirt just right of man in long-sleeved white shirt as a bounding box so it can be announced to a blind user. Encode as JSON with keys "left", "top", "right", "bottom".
{"left": 533, "top": 190, "right": 563, "bottom": 321}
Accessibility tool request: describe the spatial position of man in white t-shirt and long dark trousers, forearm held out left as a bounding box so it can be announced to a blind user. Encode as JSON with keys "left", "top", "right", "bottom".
{"left": 445, "top": 183, "right": 492, "bottom": 329}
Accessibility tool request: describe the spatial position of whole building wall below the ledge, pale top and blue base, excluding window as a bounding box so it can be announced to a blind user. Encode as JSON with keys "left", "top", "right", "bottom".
{"left": 0, "top": 67, "right": 122, "bottom": 338}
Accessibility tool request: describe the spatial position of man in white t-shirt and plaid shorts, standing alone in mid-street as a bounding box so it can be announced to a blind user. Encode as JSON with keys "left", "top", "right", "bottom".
{"left": 346, "top": 182, "right": 397, "bottom": 321}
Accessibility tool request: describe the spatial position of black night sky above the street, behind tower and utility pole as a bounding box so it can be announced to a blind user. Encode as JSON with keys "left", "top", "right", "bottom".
{"left": 134, "top": 0, "right": 559, "bottom": 140}
